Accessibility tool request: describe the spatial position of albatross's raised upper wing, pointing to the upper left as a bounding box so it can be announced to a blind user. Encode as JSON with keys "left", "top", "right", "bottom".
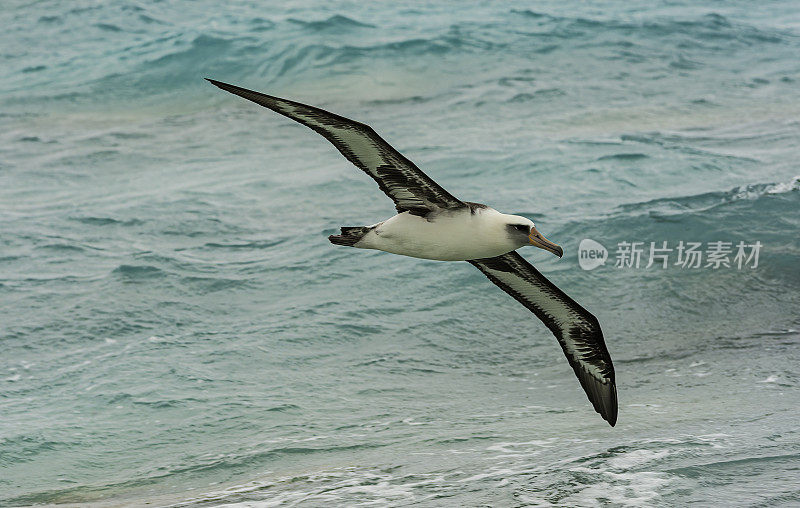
{"left": 208, "top": 79, "right": 466, "bottom": 216}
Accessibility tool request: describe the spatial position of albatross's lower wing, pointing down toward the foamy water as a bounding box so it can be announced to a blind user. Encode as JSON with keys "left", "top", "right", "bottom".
{"left": 469, "top": 252, "right": 617, "bottom": 427}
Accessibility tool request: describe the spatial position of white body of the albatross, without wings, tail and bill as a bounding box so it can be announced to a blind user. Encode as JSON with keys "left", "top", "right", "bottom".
{"left": 353, "top": 207, "right": 533, "bottom": 261}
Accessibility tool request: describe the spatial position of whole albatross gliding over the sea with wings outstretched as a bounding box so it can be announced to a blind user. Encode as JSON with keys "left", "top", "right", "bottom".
{"left": 206, "top": 78, "right": 617, "bottom": 427}
